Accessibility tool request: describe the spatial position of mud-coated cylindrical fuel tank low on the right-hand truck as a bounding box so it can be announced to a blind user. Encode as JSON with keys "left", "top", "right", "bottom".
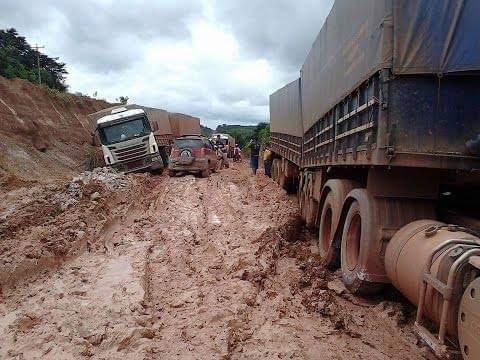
{"left": 385, "top": 220, "right": 480, "bottom": 337}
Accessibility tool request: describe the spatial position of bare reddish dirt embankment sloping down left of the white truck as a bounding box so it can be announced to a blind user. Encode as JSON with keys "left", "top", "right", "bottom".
{"left": 0, "top": 77, "right": 111, "bottom": 189}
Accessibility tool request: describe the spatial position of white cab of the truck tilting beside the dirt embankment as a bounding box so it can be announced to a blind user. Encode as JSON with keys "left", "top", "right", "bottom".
{"left": 92, "top": 106, "right": 164, "bottom": 173}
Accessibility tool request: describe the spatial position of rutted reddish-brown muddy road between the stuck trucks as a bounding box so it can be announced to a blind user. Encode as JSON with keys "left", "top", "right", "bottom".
{"left": 0, "top": 165, "right": 433, "bottom": 359}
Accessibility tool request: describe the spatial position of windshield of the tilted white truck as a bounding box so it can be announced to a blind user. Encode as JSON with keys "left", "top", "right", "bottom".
{"left": 100, "top": 118, "right": 152, "bottom": 145}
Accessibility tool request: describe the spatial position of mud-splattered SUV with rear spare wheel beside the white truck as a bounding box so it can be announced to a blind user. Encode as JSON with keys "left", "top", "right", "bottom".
{"left": 168, "top": 135, "right": 219, "bottom": 177}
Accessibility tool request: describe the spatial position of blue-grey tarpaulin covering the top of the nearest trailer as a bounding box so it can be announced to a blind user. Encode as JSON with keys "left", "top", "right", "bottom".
{"left": 301, "top": 0, "right": 480, "bottom": 130}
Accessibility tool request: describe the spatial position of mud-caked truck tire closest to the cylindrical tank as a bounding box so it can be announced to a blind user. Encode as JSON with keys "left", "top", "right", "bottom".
{"left": 340, "top": 189, "right": 384, "bottom": 295}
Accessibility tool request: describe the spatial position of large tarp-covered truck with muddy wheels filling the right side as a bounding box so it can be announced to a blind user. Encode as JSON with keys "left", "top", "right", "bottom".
{"left": 270, "top": 0, "right": 480, "bottom": 359}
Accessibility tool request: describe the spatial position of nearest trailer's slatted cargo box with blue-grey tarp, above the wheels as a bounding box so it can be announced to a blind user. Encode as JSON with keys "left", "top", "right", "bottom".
{"left": 301, "top": 0, "right": 480, "bottom": 168}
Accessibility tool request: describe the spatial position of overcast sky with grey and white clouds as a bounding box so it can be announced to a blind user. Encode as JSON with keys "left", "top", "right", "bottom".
{"left": 0, "top": 0, "right": 333, "bottom": 127}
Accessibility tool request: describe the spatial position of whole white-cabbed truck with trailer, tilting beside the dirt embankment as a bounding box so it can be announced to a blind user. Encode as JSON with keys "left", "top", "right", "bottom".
{"left": 89, "top": 104, "right": 200, "bottom": 173}
